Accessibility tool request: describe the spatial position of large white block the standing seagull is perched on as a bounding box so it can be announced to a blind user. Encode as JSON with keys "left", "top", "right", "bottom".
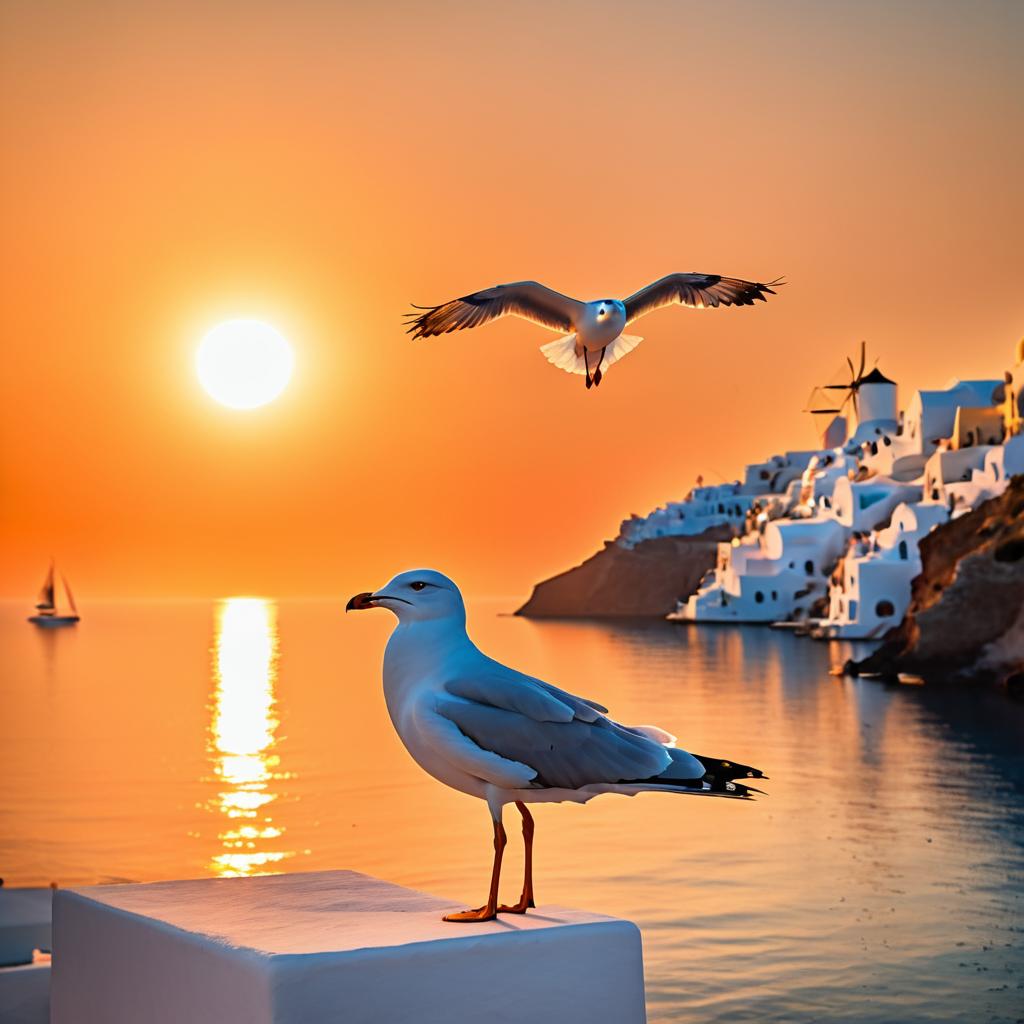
{"left": 51, "top": 871, "right": 645, "bottom": 1024}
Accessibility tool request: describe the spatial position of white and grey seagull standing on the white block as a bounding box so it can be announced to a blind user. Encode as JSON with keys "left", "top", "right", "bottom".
{"left": 345, "top": 569, "right": 765, "bottom": 922}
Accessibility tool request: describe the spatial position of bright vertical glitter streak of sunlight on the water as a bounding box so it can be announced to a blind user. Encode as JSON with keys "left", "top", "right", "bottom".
{"left": 209, "top": 597, "right": 293, "bottom": 877}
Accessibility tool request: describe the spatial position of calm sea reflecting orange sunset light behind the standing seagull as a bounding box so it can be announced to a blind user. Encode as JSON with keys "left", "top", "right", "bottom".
{"left": 0, "top": 598, "right": 1024, "bottom": 1024}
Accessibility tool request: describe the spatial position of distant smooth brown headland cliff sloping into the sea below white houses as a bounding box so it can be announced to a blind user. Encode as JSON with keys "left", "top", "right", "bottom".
{"left": 516, "top": 526, "right": 733, "bottom": 618}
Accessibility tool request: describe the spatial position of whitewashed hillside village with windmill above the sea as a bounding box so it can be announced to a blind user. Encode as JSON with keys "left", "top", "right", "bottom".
{"left": 615, "top": 340, "right": 1024, "bottom": 639}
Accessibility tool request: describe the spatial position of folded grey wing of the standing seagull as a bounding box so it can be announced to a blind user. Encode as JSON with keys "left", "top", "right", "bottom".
{"left": 425, "top": 658, "right": 703, "bottom": 790}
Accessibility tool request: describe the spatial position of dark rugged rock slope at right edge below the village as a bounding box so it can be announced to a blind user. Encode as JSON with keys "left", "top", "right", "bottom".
{"left": 847, "top": 476, "right": 1024, "bottom": 690}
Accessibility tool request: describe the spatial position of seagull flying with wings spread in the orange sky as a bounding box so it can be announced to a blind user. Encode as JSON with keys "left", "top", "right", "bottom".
{"left": 406, "top": 273, "right": 784, "bottom": 388}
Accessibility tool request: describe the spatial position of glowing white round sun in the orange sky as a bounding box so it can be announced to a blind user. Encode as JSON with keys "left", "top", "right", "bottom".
{"left": 196, "top": 319, "right": 295, "bottom": 409}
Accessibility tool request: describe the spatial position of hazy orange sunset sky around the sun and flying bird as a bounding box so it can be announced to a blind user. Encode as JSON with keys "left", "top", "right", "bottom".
{"left": 0, "top": 0, "right": 1024, "bottom": 604}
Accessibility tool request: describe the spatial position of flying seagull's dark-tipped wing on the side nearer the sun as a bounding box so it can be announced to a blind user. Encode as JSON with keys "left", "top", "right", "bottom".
{"left": 406, "top": 281, "right": 584, "bottom": 339}
